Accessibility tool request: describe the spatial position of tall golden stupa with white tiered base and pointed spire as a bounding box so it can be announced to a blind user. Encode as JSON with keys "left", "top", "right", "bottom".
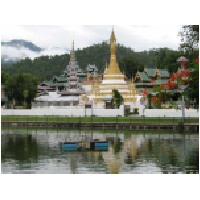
{"left": 90, "top": 29, "right": 136, "bottom": 110}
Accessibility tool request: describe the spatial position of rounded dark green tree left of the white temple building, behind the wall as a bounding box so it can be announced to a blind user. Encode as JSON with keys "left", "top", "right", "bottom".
{"left": 5, "top": 73, "right": 38, "bottom": 108}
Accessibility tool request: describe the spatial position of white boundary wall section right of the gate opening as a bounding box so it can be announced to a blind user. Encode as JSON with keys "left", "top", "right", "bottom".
{"left": 139, "top": 107, "right": 199, "bottom": 117}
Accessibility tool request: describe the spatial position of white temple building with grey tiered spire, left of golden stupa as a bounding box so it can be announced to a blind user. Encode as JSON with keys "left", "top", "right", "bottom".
{"left": 32, "top": 42, "right": 85, "bottom": 108}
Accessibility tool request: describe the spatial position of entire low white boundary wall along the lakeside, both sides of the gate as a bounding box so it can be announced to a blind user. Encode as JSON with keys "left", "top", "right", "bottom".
{"left": 1, "top": 106, "right": 199, "bottom": 117}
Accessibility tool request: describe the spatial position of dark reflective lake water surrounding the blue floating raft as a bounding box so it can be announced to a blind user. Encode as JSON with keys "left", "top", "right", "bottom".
{"left": 1, "top": 129, "right": 199, "bottom": 174}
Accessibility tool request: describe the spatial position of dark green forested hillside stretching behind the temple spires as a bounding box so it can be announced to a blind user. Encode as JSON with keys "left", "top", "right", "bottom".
{"left": 1, "top": 42, "right": 199, "bottom": 81}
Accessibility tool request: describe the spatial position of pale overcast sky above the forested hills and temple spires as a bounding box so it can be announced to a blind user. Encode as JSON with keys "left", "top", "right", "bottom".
{"left": 1, "top": 25, "right": 181, "bottom": 58}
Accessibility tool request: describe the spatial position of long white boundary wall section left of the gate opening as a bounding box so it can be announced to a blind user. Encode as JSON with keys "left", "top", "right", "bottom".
{"left": 1, "top": 106, "right": 124, "bottom": 117}
